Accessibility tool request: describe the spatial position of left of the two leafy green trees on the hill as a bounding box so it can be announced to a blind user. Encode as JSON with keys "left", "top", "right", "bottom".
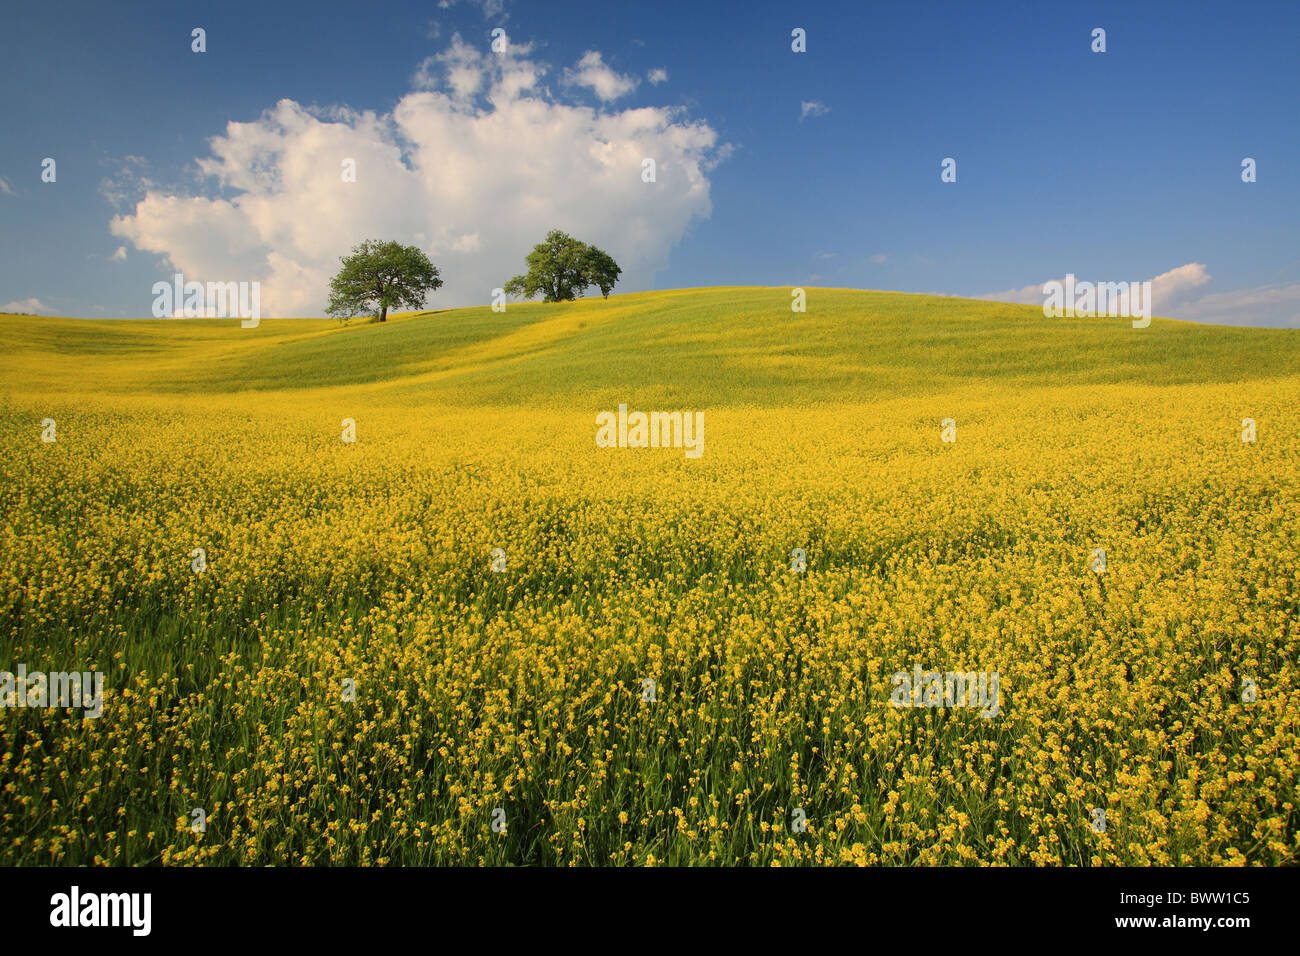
{"left": 325, "top": 239, "right": 442, "bottom": 323}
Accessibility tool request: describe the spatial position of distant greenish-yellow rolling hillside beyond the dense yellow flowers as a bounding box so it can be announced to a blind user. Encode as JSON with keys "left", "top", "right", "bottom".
{"left": 0, "top": 287, "right": 1300, "bottom": 406}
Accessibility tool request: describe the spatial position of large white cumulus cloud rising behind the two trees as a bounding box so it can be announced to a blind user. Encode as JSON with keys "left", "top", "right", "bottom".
{"left": 109, "top": 35, "right": 728, "bottom": 316}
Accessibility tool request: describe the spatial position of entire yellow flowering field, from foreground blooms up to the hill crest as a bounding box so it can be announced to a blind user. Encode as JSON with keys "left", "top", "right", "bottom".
{"left": 0, "top": 289, "right": 1300, "bottom": 866}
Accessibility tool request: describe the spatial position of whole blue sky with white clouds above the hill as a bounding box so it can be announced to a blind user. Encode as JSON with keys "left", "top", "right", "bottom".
{"left": 0, "top": 0, "right": 1300, "bottom": 325}
